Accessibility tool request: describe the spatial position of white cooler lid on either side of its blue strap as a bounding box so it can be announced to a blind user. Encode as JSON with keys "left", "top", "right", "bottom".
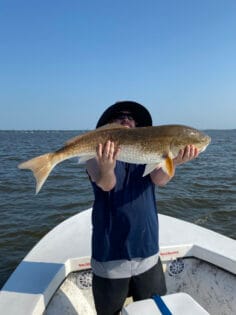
{"left": 121, "top": 292, "right": 210, "bottom": 315}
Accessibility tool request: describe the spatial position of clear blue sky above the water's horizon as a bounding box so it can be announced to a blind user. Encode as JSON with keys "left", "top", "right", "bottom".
{"left": 0, "top": 0, "right": 236, "bottom": 130}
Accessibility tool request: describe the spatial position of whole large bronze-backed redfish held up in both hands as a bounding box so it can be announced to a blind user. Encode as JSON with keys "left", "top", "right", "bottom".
{"left": 18, "top": 124, "right": 211, "bottom": 194}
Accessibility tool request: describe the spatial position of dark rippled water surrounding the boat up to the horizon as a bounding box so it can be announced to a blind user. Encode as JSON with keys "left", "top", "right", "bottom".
{"left": 0, "top": 130, "right": 236, "bottom": 287}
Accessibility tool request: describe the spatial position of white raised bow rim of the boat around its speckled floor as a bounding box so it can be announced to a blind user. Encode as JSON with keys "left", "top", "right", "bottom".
{"left": 0, "top": 209, "right": 236, "bottom": 315}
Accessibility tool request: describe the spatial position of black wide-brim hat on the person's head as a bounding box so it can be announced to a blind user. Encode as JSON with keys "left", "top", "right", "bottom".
{"left": 96, "top": 101, "right": 152, "bottom": 128}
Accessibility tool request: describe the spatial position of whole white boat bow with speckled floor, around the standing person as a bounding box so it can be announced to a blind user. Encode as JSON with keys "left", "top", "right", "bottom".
{"left": 0, "top": 209, "right": 236, "bottom": 315}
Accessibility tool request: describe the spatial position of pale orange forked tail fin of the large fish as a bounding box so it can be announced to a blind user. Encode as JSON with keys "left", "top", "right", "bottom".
{"left": 18, "top": 153, "right": 57, "bottom": 194}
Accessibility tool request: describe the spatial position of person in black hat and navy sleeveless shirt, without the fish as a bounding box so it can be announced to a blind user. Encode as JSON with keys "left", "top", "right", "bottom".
{"left": 86, "top": 101, "right": 199, "bottom": 315}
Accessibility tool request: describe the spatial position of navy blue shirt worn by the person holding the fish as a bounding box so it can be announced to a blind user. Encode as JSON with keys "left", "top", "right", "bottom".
{"left": 92, "top": 161, "right": 159, "bottom": 262}
